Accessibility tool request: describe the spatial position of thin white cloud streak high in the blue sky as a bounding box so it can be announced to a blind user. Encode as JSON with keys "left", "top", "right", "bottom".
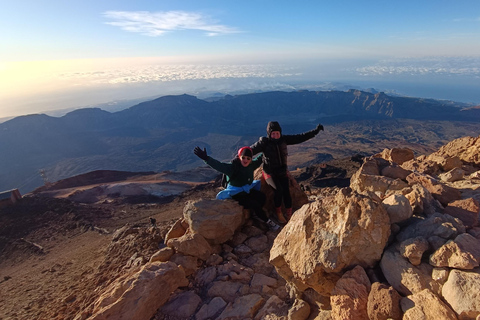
{"left": 104, "top": 11, "right": 241, "bottom": 37}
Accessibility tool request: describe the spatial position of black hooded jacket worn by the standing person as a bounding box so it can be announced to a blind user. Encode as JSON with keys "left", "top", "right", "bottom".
{"left": 250, "top": 121, "right": 318, "bottom": 176}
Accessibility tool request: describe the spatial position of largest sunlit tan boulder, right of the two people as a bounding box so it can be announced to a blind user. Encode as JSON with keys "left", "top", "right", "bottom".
{"left": 270, "top": 189, "right": 390, "bottom": 295}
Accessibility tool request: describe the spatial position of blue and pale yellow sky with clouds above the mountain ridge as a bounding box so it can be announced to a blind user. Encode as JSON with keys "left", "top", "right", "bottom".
{"left": 0, "top": 0, "right": 480, "bottom": 118}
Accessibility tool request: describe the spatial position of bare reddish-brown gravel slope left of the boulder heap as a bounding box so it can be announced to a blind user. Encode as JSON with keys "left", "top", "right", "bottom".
{"left": 0, "top": 179, "right": 219, "bottom": 319}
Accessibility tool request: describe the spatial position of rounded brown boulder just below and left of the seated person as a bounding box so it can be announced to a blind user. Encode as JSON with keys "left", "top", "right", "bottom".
{"left": 183, "top": 200, "right": 245, "bottom": 244}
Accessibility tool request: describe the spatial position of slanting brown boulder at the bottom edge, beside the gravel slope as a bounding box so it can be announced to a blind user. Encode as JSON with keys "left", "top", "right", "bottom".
{"left": 89, "top": 262, "right": 188, "bottom": 320}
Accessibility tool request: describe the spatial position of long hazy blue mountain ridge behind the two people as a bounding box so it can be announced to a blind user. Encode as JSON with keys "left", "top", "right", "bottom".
{"left": 0, "top": 89, "right": 480, "bottom": 190}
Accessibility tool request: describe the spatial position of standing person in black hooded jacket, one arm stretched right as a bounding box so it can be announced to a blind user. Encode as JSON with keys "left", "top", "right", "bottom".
{"left": 250, "top": 121, "right": 323, "bottom": 223}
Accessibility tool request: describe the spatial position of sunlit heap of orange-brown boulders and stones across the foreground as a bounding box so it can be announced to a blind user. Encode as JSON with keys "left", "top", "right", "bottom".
{"left": 0, "top": 137, "right": 480, "bottom": 320}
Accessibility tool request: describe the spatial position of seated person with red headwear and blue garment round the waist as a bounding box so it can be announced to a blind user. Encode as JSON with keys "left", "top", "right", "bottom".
{"left": 193, "top": 147, "right": 279, "bottom": 230}
